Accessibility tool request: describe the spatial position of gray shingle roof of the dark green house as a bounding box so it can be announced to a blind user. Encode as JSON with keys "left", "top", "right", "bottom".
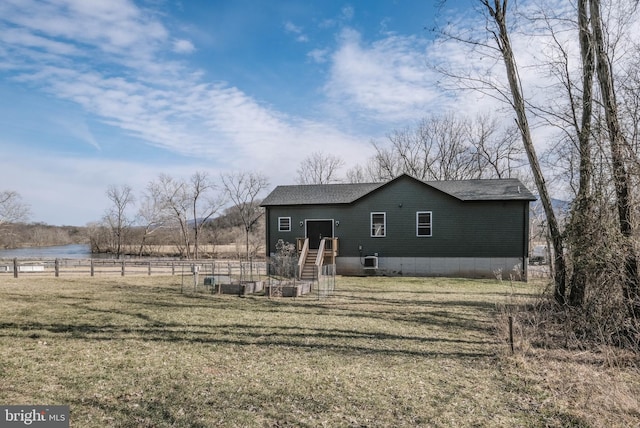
{"left": 262, "top": 174, "right": 536, "bottom": 206}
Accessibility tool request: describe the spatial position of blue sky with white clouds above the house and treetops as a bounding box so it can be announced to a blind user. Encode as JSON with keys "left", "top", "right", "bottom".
{"left": 0, "top": 0, "right": 568, "bottom": 225}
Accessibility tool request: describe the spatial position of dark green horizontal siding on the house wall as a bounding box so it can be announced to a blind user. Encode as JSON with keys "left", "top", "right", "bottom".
{"left": 267, "top": 179, "right": 528, "bottom": 257}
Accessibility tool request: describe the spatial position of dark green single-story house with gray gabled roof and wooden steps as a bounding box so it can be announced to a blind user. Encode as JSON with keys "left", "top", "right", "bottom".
{"left": 262, "top": 174, "right": 536, "bottom": 279}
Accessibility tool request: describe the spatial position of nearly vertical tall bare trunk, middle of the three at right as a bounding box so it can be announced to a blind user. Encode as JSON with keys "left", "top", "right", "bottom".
{"left": 569, "top": 0, "right": 596, "bottom": 306}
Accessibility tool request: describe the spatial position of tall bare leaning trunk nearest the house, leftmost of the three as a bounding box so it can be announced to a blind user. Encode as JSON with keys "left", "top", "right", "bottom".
{"left": 480, "top": 0, "right": 566, "bottom": 304}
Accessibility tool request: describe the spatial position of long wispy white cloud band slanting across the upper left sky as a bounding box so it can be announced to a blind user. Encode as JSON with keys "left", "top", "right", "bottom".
{"left": 0, "top": 0, "right": 370, "bottom": 176}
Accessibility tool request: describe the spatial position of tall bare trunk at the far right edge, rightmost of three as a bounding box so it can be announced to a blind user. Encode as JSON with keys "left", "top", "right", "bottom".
{"left": 589, "top": 0, "right": 640, "bottom": 317}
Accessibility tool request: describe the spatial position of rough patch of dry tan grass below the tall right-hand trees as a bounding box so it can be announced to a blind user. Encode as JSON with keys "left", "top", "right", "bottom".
{"left": 497, "top": 284, "right": 640, "bottom": 427}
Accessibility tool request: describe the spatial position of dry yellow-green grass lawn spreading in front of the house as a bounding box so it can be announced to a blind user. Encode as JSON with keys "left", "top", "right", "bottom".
{"left": 0, "top": 276, "right": 640, "bottom": 427}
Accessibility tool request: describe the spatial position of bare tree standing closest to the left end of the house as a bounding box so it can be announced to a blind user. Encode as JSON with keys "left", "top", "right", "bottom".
{"left": 221, "top": 172, "right": 269, "bottom": 260}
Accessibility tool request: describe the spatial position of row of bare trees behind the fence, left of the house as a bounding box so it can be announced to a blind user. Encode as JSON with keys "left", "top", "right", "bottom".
{"left": 89, "top": 171, "right": 269, "bottom": 259}
